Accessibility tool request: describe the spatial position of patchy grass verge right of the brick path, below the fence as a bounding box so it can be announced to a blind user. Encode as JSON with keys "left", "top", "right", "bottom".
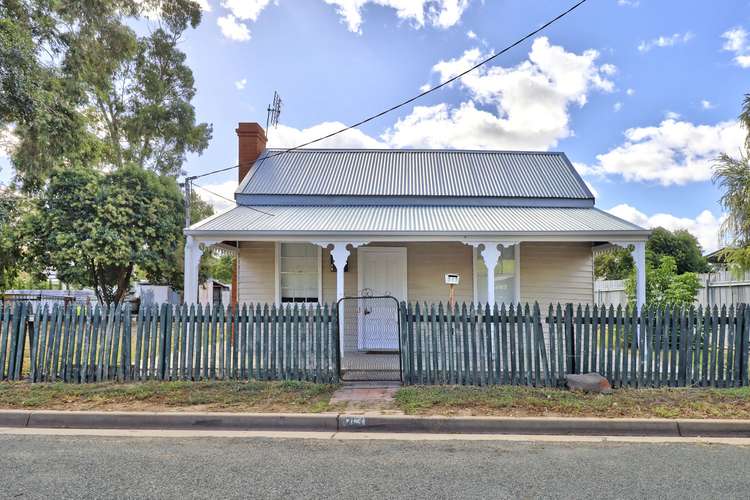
{"left": 395, "top": 386, "right": 750, "bottom": 419}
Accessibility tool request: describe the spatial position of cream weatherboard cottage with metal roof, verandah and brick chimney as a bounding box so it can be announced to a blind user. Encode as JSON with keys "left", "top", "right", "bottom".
{"left": 185, "top": 123, "right": 649, "bottom": 364}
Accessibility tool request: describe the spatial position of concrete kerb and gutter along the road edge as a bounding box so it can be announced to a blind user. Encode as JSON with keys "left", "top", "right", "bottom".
{"left": 0, "top": 410, "right": 750, "bottom": 438}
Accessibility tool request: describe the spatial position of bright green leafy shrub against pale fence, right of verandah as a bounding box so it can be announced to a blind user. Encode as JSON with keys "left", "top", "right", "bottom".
{"left": 625, "top": 255, "right": 701, "bottom": 306}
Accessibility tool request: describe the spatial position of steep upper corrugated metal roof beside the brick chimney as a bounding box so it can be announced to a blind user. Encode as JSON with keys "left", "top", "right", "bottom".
{"left": 237, "top": 149, "right": 593, "bottom": 199}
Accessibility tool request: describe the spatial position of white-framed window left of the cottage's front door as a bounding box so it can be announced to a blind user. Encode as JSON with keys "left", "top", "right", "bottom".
{"left": 278, "top": 243, "right": 320, "bottom": 303}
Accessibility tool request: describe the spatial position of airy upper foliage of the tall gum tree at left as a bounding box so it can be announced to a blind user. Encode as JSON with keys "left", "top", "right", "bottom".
{"left": 0, "top": 0, "right": 211, "bottom": 191}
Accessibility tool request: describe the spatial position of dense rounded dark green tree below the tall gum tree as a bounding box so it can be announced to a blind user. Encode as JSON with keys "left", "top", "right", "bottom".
{"left": 20, "top": 166, "right": 183, "bottom": 303}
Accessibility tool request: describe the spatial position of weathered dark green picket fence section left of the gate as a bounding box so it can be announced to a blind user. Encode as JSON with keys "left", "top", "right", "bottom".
{"left": 0, "top": 303, "right": 339, "bottom": 383}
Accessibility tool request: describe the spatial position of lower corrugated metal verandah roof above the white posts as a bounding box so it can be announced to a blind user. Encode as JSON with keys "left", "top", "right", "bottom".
{"left": 189, "top": 206, "right": 645, "bottom": 234}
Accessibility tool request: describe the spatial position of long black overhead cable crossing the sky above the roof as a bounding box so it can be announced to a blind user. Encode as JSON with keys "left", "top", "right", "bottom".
{"left": 189, "top": 0, "right": 587, "bottom": 180}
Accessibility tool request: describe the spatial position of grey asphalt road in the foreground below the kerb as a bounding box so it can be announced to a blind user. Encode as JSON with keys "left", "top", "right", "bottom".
{"left": 0, "top": 435, "right": 750, "bottom": 499}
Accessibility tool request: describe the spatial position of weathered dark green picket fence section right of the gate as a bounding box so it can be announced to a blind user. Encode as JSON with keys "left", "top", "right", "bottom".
{"left": 401, "top": 303, "right": 750, "bottom": 387}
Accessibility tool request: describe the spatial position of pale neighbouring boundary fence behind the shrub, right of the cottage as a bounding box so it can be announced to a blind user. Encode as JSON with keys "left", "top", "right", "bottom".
{"left": 594, "top": 270, "right": 750, "bottom": 308}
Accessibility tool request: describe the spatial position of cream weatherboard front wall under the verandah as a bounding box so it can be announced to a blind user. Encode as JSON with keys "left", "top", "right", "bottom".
{"left": 238, "top": 242, "right": 594, "bottom": 304}
